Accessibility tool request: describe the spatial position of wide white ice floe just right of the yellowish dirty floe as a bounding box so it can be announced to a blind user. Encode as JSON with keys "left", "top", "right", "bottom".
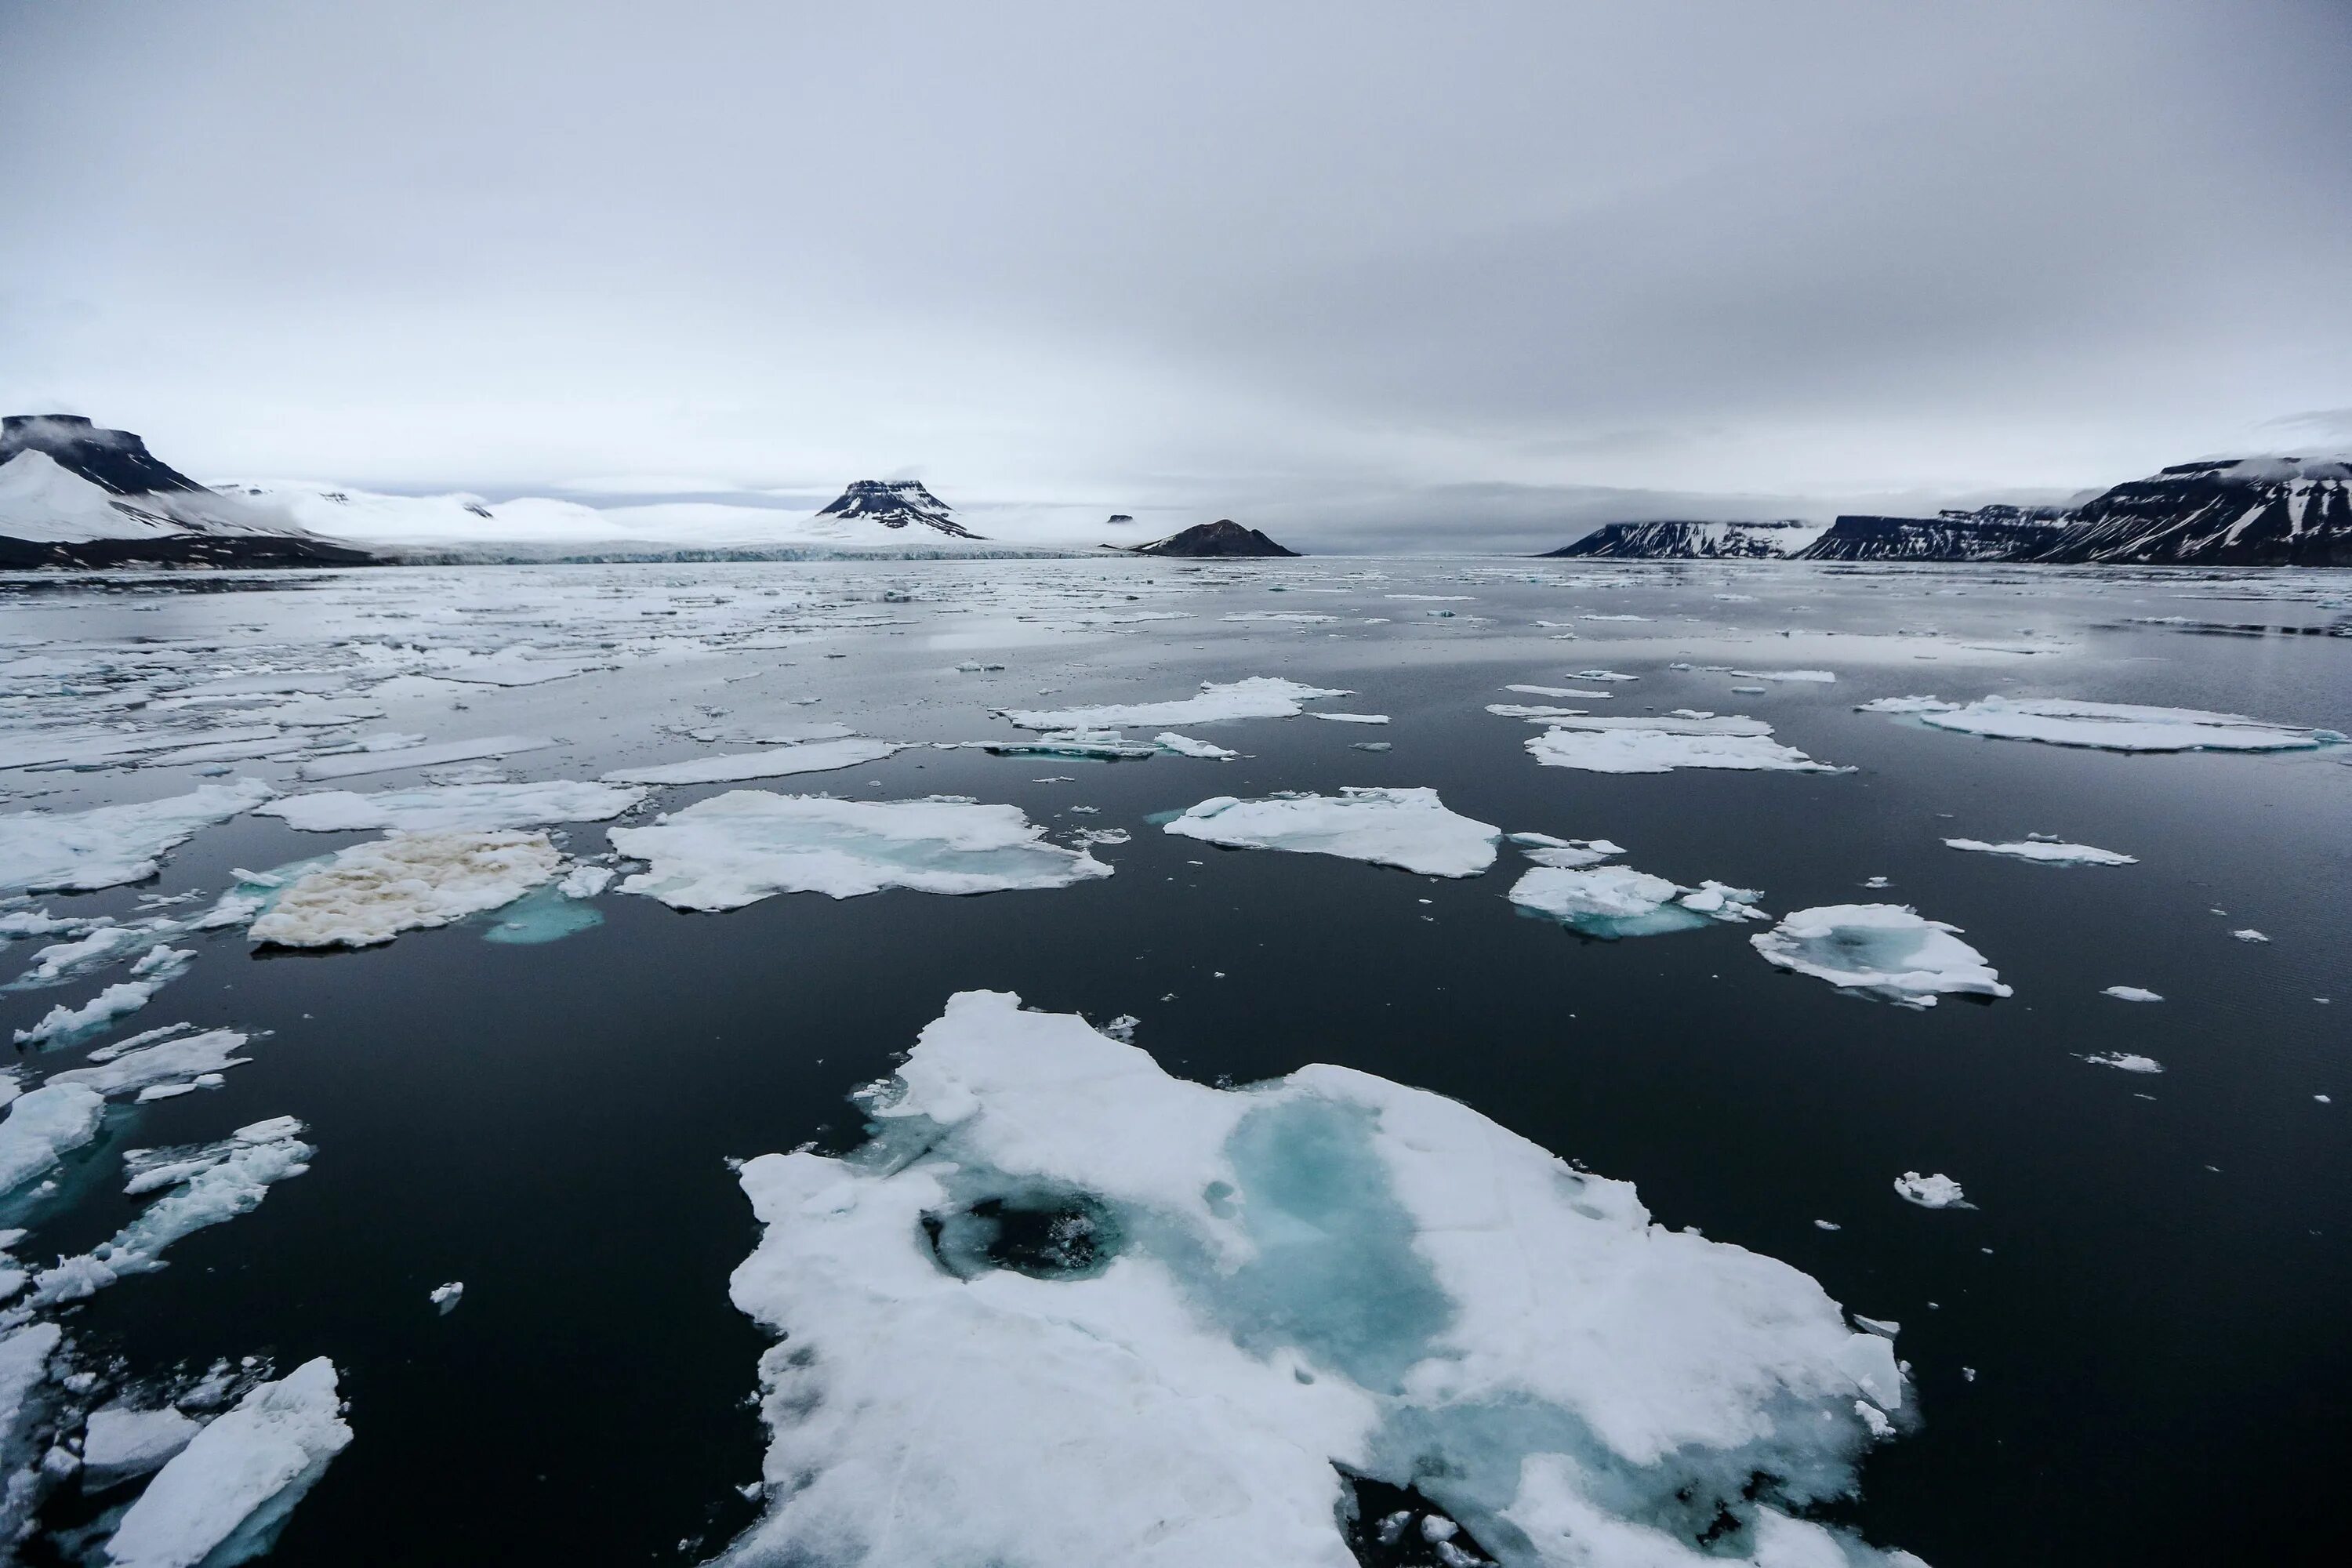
{"left": 612, "top": 789, "right": 1110, "bottom": 909}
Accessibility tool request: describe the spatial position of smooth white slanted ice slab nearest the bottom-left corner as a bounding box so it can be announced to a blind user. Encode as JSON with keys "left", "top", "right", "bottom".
{"left": 106, "top": 1356, "right": 350, "bottom": 1568}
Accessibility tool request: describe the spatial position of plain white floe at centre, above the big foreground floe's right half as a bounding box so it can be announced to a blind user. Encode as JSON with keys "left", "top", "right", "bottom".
{"left": 1162, "top": 787, "right": 1503, "bottom": 877}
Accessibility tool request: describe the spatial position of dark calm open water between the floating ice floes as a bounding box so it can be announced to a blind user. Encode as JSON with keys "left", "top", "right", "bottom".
{"left": 0, "top": 572, "right": 2352, "bottom": 1568}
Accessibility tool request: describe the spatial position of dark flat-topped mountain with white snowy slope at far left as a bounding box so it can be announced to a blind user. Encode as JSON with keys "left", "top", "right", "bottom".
{"left": 0, "top": 414, "right": 374, "bottom": 572}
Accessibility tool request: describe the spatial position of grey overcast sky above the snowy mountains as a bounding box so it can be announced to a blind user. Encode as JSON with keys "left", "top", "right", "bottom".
{"left": 0, "top": 0, "right": 2352, "bottom": 543}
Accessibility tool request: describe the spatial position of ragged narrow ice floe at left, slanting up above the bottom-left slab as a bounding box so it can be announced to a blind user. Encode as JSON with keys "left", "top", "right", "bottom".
{"left": 28, "top": 1114, "right": 318, "bottom": 1307}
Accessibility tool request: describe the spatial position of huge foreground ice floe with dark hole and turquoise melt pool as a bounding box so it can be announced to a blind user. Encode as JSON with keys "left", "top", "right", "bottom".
{"left": 724, "top": 992, "right": 1917, "bottom": 1568}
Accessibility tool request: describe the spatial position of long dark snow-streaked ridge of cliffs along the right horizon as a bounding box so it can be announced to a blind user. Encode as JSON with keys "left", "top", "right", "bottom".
{"left": 1552, "top": 456, "right": 2352, "bottom": 567}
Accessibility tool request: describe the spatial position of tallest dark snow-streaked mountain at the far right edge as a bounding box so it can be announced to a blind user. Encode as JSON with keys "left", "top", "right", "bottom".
{"left": 2032, "top": 454, "right": 2352, "bottom": 567}
